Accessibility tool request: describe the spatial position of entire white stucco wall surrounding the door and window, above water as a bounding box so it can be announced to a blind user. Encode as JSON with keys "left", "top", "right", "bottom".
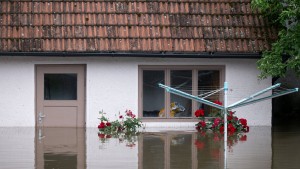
{"left": 0, "top": 57, "right": 271, "bottom": 127}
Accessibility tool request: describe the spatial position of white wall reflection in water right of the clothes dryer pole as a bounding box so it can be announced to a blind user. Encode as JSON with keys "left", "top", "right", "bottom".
{"left": 227, "top": 126, "right": 273, "bottom": 169}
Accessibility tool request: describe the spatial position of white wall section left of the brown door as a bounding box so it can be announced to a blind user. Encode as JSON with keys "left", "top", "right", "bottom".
{"left": 0, "top": 58, "right": 35, "bottom": 126}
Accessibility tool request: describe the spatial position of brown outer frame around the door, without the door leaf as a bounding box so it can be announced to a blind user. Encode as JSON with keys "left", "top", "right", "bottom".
{"left": 34, "top": 64, "right": 86, "bottom": 128}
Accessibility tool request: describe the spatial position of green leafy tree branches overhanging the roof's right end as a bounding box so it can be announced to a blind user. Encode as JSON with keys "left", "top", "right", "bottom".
{"left": 251, "top": 0, "right": 300, "bottom": 78}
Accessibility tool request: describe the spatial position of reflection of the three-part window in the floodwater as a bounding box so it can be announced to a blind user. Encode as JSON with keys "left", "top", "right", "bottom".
{"left": 139, "top": 131, "right": 223, "bottom": 169}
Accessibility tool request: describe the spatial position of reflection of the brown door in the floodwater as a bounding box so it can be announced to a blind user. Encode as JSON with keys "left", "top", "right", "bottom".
{"left": 35, "top": 128, "right": 85, "bottom": 169}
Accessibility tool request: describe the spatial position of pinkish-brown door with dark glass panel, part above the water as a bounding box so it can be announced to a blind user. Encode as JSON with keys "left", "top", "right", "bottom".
{"left": 36, "top": 65, "right": 85, "bottom": 127}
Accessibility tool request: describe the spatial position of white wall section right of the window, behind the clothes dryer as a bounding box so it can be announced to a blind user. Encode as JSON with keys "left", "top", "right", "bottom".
{"left": 226, "top": 60, "right": 272, "bottom": 126}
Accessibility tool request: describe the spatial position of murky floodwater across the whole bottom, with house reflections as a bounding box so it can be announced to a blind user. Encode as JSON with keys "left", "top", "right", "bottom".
{"left": 0, "top": 125, "right": 300, "bottom": 169}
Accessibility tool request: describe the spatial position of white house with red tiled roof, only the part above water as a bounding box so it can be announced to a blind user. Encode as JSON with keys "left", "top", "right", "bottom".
{"left": 0, "top": 0, "right": 276, "bottom": 127}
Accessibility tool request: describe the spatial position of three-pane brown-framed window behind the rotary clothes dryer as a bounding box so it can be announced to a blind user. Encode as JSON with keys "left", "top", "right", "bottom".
{"left": 139, "top": 66, "right": 224, "bottom": 119}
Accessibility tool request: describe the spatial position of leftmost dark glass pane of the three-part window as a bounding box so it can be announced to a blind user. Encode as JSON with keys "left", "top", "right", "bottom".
{"left": 143, "top": 70, "right": 165, "bottom": 117}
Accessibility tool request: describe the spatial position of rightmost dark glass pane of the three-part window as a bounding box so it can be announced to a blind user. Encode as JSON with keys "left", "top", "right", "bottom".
{"left": 198, "top": 70, "right": 220, "bottom": 116}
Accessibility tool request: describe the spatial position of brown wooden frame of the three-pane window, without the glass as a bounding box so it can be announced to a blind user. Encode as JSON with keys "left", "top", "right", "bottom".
{"left": 138, "top": 65, "right": 225, "bottom": 122}
